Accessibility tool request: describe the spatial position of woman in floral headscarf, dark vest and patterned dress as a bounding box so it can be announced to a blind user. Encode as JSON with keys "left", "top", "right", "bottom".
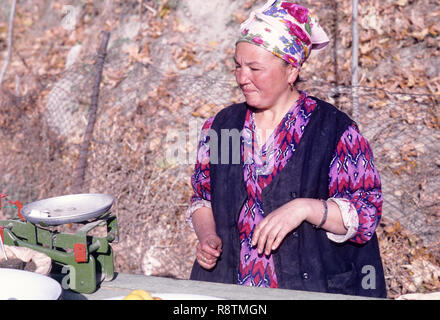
{"left": 187, "top": 0, "right": 386, "bottom": 297}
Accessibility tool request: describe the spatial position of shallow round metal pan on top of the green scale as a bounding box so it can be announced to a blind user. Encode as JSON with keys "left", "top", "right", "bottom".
{"left": 21, "top": 193, "right": 114, "bottom": 226}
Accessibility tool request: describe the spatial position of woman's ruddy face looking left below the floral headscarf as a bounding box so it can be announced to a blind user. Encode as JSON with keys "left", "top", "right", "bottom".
{"left": 234, "top": 42, "right": 296, "bottom": 109}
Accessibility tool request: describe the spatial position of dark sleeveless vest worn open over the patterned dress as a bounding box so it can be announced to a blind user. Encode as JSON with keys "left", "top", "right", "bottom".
{"left": 190, "top": 98, "right": 386, "bottom": 297}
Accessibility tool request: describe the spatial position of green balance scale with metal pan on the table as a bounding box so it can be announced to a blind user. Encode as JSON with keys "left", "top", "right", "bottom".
{"left": 0, "top": 194, "right": 119, "bottom": 293}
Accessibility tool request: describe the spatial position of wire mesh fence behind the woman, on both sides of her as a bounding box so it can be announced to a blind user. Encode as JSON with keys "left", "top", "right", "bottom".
{"left": 1, "top": 47, "right": 440, "bottom": 275}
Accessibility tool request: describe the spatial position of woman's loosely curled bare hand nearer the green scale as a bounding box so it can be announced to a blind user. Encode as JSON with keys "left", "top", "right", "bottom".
{"left": 196, "top": 233, "right": 223, "bottom": 270}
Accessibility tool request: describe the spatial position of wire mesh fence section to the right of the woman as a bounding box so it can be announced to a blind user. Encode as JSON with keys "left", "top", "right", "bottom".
{"left": 316, "top": 82, "right": 440, "bottom": 242}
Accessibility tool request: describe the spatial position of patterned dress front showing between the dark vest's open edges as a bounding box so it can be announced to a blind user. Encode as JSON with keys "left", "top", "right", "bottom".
{"left": 238, "top": 93, "right": 316, "bottom": 288}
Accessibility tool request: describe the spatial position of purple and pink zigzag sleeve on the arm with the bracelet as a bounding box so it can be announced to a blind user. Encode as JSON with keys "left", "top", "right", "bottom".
{"left": 329, "top": 125, "right": 383, "bottom": 244}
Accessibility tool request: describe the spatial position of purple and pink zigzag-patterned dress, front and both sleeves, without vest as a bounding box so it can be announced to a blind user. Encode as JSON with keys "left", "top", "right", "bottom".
{"left": 191, "top": 92, "right": 382, "bottom": 287}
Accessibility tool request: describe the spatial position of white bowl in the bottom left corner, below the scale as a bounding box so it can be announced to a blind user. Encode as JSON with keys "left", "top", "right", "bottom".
{"left": 0, "top": 269, "right": 62, "bottom": 300}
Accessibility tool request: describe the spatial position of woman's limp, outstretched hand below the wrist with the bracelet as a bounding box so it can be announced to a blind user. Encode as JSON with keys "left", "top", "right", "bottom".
{"left": 252, "top": 199, "right": 310, "bottom": 255}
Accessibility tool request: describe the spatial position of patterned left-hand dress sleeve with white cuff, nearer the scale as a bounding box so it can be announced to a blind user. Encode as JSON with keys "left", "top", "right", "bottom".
{"left": 185, "top": 117, "right": 214, "bottom": 226}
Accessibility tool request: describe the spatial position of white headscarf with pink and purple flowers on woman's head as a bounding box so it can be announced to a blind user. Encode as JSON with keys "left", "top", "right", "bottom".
{"left": 237, "top": 0, "right": 329, "bottom": 68}
